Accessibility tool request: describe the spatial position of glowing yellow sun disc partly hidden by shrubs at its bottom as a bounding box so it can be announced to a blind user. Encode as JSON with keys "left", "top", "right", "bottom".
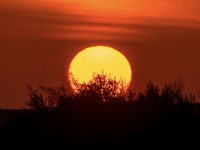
{"left": 69, "top": 46, "right": 132, "bottom": 91}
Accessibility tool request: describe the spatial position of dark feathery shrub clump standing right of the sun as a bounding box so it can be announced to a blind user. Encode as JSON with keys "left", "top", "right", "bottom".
{"left": 136, "top": 79, "right": 195, "bottom": 105}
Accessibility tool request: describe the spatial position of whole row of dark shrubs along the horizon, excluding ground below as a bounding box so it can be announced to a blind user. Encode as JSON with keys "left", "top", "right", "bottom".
{"left": 25, "top": 74, "right": 195, "bottom": 110}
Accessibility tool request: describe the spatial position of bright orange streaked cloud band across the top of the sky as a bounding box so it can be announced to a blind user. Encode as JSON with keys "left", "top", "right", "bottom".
{"left": 0, "top": 0, "right": 200, "bottom": 40}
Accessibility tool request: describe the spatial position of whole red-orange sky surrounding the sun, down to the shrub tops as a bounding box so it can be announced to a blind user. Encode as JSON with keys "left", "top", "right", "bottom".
{"left": 0, "top": 0, "right": 200, "bottom": 109}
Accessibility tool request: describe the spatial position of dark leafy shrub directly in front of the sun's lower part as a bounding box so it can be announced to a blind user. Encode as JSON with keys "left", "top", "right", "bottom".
{"left": 71, "top": 71, "right": 127, "bottom": 102}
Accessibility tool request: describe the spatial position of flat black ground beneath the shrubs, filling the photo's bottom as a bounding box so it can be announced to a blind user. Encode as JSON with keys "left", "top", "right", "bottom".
{"left": 0, "top": 102, "right": 200, "bottom": 149}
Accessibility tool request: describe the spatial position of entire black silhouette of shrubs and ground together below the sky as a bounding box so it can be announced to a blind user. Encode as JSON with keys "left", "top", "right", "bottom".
{"left": 1, "top": 73, "right": 200, "bottom": 149}
